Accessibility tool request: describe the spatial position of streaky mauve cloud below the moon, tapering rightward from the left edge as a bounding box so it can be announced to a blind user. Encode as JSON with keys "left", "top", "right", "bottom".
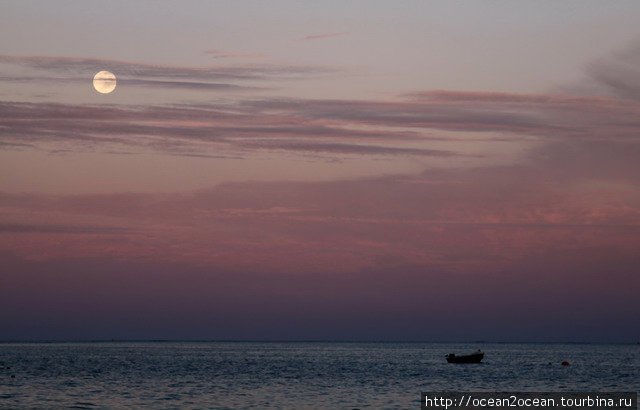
{"left": 0, "top": 98, "right": 455, "bottom": 157}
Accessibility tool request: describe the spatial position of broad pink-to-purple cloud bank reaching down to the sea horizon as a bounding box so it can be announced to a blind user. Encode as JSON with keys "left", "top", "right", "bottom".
{"left": 0, "top": 144, "right": 640, "bottom": 341}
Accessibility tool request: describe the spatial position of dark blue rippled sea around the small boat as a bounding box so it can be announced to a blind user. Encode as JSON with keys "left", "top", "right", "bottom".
{"left": 0, "top": 342, "right": 640, "bottom": 409}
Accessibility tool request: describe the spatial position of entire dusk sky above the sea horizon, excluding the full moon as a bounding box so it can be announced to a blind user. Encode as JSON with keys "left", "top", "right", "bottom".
{"left": 0, "top": 0, "right": 640, "bottom": 343}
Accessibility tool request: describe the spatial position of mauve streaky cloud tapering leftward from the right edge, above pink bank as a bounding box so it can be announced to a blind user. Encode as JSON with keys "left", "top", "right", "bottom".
{"left": 245, "top": 91, "right": 640, "bottom": 140}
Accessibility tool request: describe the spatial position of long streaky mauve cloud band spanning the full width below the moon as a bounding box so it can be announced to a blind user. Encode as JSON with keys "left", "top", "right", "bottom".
{"left": 0, "top": 80, "right": 640, "bottom": 156}
